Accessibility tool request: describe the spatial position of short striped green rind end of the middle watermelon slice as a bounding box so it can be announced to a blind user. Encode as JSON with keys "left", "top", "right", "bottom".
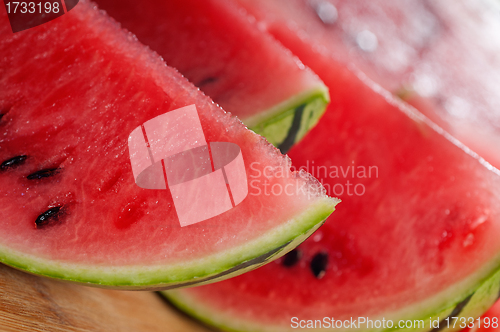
{"left": 243, "top": 84, "right": 330, "bottom": 153}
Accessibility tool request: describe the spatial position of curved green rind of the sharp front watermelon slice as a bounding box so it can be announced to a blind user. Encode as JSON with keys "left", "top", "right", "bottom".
{"left": 0, "top": 196, "right": 338, "bottom": 290}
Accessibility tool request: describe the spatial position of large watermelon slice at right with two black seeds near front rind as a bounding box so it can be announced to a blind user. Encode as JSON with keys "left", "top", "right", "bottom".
{"left": 165, "top": 1, "right": 500, "bottom": 331}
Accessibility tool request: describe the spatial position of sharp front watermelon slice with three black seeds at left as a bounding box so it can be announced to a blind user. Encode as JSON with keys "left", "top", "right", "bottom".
{"left": 0, "top": 1, "right": 337, "bottom": 289}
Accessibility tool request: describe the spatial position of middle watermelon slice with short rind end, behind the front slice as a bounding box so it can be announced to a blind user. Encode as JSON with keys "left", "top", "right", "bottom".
{"left": 97, "top": 0, "right": 328, "bottom": 152}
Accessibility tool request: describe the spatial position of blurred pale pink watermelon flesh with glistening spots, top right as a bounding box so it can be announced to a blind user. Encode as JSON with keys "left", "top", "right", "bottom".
{"left": 234, "top": 0, "right": 500, "bottom": 168}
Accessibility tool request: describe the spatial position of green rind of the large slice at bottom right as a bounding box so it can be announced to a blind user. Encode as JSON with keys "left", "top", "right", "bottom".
{"left": 162, "top": 257, "right": 500, "bottom": 332}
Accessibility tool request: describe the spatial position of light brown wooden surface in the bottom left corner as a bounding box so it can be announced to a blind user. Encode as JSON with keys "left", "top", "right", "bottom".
{"left": 0, "top": 264, "right": 213, "bottom": 332}
